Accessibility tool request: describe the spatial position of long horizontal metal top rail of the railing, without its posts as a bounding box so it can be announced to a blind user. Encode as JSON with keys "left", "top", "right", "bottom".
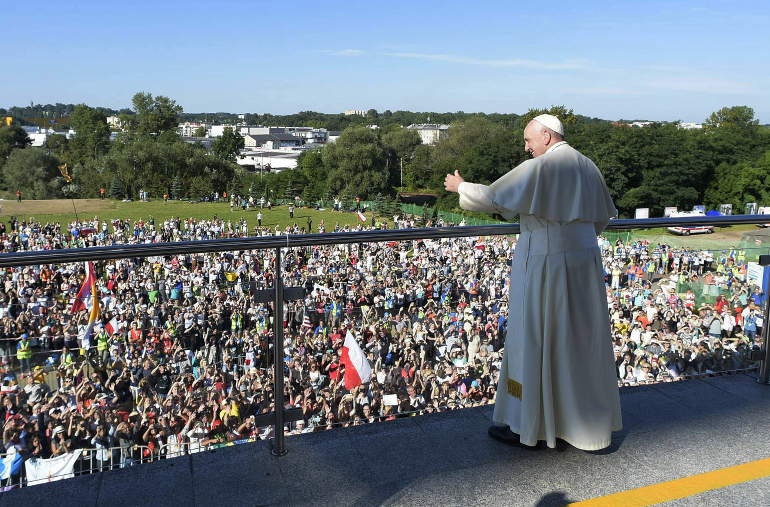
{"left": 0, "top": 215, "right": 770, "bottom": 268}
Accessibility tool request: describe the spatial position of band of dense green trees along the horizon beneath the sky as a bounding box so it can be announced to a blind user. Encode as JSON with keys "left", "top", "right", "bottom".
{"left": 0, "top": 97, "right": 770, "bottom": 217}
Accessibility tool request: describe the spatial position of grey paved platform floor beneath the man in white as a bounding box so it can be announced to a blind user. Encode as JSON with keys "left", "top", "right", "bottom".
{"left": 7, "top": 373, "right": 770, "bottom": 507}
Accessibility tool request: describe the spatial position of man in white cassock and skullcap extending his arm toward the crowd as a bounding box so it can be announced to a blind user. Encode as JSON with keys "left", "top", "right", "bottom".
{"left": 445, "top": 115, "right": 622, "bottom": 451}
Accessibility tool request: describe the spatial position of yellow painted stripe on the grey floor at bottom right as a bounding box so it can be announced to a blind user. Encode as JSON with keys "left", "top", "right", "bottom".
{"left": 567, "top": 458, "right": 770, "bottom": 507}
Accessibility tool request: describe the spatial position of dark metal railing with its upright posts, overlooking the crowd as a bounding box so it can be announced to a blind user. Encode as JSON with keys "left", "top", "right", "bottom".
{"left": 0, "top": 215, "right": 770, "bottom": 456}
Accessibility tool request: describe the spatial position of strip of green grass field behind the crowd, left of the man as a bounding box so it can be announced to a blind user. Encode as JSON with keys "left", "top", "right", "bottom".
{"left": 0, "top": 199, "right": 393, "bottom": 232}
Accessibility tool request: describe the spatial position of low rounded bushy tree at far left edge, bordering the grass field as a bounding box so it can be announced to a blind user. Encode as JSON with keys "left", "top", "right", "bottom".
{"left": 2, "top": 148, "right": 66, "bottom": 199}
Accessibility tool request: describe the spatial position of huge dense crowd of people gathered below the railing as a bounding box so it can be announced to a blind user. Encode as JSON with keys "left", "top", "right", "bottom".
{"left": 0, "top": 210, "right": 763, "bottom": 484}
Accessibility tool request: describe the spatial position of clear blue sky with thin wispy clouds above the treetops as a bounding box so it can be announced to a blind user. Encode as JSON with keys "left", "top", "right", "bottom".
{"left": 0, "top": 0, "right": 770, "bottom": 123}
